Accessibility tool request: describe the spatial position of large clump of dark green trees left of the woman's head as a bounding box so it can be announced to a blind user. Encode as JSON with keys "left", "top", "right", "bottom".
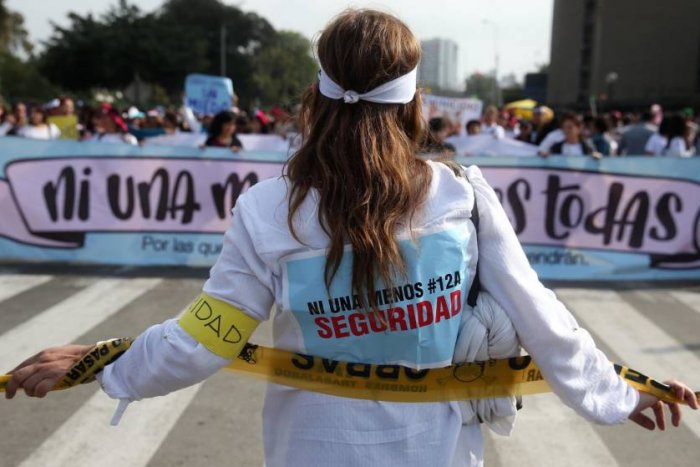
{"left": 33, "top": 0, "right": 316, "bottom": 106}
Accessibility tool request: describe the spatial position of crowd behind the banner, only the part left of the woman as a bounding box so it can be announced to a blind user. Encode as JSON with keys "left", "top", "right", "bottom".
{"left": 0, "top": 96, "right": 295, "bottom": 151}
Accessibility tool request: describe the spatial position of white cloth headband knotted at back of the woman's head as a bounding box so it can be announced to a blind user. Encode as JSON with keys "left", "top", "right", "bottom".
{"left": 318, "top": 68, "right": 418, "bottom": 104}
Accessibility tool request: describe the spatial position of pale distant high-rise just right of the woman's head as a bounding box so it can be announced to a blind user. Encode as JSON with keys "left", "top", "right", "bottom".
{"left": 418, "top": 39, "right": 462, "bottom": 91}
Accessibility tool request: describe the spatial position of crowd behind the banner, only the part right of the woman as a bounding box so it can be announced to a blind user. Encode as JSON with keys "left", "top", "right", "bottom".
{"left": 426, "top": 104, "right": 700, "bottom": 158}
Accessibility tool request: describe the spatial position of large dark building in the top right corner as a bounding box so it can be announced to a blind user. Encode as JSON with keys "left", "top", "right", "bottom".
{"left": 547, "top": 0, "right": 700, "bottom": 108}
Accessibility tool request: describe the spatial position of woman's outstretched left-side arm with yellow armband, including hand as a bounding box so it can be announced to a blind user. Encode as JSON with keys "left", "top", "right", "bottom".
{"left": 6, "top": 190, "right": 273, "bottom": 401}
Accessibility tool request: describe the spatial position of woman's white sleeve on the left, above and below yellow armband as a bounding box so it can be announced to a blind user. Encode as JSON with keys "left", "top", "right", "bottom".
{"left": 98, "top": 195, "right": 274, "bottom": 401}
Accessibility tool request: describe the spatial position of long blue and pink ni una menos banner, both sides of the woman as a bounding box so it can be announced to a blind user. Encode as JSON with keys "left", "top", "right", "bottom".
{"left": 0, "top": 138, "right": 700, "bottom": 280}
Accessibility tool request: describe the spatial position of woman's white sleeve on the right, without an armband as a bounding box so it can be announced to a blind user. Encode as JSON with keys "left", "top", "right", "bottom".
{"left": 467, "top": 166, "right": 639, "bottom": 424}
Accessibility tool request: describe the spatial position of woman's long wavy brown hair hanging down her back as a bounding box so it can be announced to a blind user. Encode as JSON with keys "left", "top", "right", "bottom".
{"left": 287, "top": 10, "right": 431, "bottom": 309}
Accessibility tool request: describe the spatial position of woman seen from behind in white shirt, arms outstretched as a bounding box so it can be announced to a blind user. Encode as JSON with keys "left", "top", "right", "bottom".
{"left": 8, "top": 10, "right": 695, "bottom": 467}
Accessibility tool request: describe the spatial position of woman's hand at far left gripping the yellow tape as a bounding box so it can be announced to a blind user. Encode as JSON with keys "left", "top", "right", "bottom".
{"left": 5, "top": 344, "right": 93, "bottom": 399}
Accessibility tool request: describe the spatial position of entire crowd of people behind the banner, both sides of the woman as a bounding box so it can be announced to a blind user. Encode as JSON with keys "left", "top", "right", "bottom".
{"left": 0, "top": 96, "right": 700, "bottom": 158}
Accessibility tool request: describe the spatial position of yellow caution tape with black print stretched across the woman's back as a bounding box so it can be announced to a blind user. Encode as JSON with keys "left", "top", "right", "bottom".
{"left": 0, "top": 339, "right": 700, "bottom": 404}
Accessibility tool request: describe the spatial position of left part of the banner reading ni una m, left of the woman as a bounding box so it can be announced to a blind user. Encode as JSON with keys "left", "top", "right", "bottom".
{"left": 0, "top": 138, "right": 286, "bottom": 266}
